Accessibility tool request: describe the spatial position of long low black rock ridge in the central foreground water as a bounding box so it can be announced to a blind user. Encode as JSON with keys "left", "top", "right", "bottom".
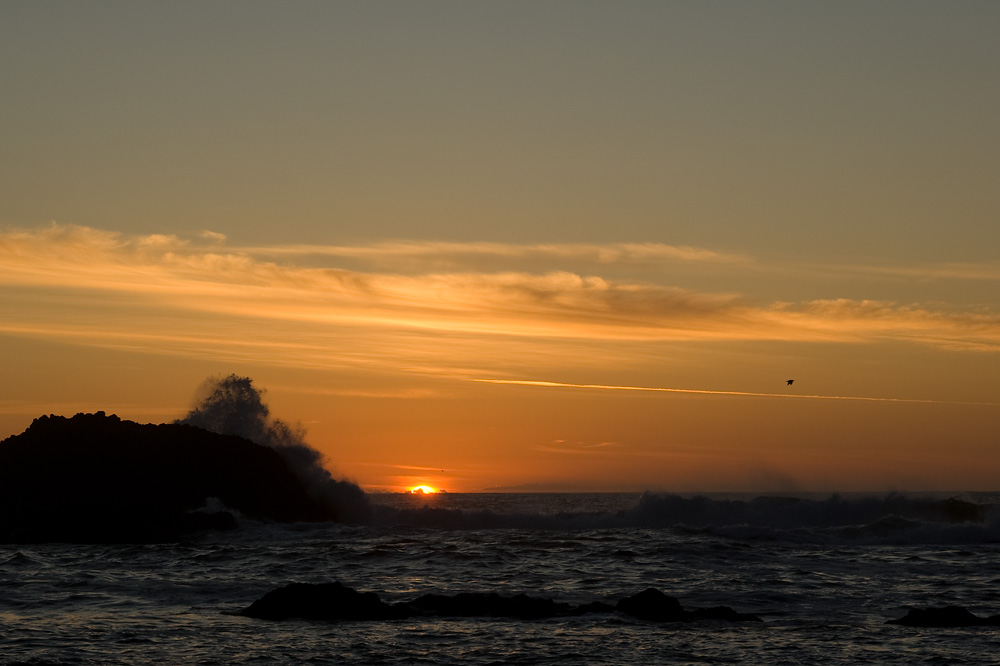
{"left": 240, "top": 583, "right": 761, "bottom": 622}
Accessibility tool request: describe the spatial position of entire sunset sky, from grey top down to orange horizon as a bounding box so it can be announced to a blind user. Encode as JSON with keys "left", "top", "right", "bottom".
{"left": 0, "top": 0, "right": 1000, "bottom": 492}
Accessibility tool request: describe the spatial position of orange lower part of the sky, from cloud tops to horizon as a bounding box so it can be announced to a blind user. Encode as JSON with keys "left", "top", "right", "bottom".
{"left": 0, "top": 225, "right": 1000, "bottom": 491}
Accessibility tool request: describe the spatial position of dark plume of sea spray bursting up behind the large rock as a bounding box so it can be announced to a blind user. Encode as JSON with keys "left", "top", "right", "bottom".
{"left": 175, "top": 374, "right": 371, "bottom": 523}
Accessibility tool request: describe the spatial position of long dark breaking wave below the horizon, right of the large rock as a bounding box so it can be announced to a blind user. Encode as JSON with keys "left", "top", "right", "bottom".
{"left": 373, "top": 493, "right": 1000, "bottom": 544}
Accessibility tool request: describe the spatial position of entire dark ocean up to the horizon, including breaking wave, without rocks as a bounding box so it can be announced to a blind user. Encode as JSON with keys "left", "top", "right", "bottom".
{"left": 0, "top": 493, "right": 1000, "bottom": 665}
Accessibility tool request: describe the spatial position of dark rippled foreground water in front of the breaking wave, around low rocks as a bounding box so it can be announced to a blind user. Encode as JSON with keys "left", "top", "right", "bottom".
{"left": 0, "top": 500, "right": 1000, "bottom": 665}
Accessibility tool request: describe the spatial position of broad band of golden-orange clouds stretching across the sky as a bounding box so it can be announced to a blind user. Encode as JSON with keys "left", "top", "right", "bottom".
{"left": 0, "top": 224, "right": 1000, "bottom": 376}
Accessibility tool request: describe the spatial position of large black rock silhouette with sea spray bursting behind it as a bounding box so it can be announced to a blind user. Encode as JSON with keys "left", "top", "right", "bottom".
{"left": 0, "top": 412, "right": 337, "bottom": 543}
